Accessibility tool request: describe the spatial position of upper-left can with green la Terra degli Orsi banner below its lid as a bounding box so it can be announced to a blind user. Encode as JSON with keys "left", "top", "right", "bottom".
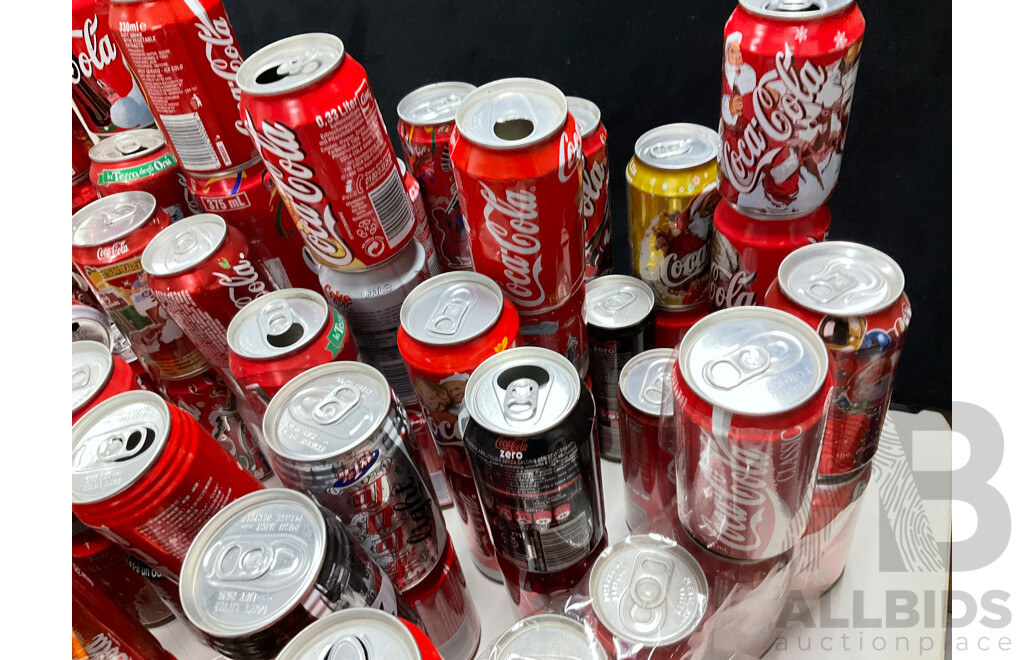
{"left": 89, "top": 128, "right": 191, "bottom": 222}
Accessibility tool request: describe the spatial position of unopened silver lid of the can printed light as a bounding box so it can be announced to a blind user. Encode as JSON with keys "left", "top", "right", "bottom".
{"left": 263, "top": 361, "right": 391, "bottom": 460}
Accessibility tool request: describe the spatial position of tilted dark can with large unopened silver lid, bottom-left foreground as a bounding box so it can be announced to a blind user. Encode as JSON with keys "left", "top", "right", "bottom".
{"left": 180, "top": 488, "right": 398, "bottom": 660}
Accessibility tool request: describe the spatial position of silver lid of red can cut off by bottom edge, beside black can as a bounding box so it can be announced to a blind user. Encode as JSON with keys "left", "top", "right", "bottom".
{"left": 276, "top": 608, "right": 423, "bottom": 660}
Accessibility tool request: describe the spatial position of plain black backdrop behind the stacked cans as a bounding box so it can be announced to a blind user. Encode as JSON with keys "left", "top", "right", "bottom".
{"left": 224, "top": 0, "right": 950, "bottom": 409}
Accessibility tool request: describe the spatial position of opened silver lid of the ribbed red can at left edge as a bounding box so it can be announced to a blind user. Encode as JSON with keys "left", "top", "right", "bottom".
{"left": 71, "top": 390, "right": 171, "bottom": 504}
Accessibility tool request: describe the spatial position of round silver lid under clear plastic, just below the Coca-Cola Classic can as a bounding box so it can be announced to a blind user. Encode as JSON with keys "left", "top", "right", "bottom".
{"left": 589, "top": 534, "right": 708, "bottom": 647}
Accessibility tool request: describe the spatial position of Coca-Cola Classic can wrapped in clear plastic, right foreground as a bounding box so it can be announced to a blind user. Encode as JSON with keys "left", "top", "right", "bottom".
{"left": 664, "top": 307, "right": 831, "bottom": 560}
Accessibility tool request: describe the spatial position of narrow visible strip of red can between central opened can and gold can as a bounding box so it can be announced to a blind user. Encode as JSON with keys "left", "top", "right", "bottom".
{"left": 565, "top": 96, "right": 611, "bottom": 281}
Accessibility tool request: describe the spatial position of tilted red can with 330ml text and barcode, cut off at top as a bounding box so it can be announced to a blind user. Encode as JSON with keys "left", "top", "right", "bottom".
{"left": 110, "top": 0, "right": 253, "bottom": 172}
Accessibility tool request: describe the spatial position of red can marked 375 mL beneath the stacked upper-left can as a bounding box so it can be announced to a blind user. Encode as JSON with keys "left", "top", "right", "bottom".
{"left": 185, "top": 157, "right": 319, "bottom": 290}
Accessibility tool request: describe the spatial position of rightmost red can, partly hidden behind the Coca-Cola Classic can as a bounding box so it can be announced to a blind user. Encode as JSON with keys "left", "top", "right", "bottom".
{"left": 765, "top": 241, "right": 910, "bottom": 475}
